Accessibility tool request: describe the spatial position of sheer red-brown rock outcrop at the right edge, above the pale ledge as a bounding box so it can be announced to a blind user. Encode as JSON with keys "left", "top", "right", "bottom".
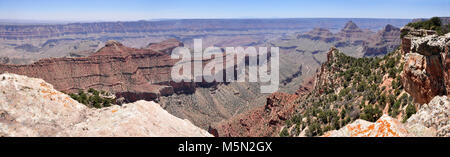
{"left": 401, "top": 27, "right": 450, "bottom": 104}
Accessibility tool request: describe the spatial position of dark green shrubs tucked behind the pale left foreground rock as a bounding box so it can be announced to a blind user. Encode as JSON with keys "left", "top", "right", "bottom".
{"left": 69, "top": 88, "right": 115, "bottom": 108}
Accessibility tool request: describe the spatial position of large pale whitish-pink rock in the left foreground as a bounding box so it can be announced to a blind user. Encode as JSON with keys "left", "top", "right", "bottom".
{"left": 0, "top": 73, "right": 212, "bottom": 136}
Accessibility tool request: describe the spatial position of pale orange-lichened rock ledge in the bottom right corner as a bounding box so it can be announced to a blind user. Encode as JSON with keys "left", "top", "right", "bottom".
{"left": 324, "top": 96, "right": 450, "bottom": 137}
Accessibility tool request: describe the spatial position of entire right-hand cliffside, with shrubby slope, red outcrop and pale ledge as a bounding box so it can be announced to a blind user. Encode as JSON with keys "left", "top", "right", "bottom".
{"left": 217, "top": 20, "right": 450, "bottom": 136}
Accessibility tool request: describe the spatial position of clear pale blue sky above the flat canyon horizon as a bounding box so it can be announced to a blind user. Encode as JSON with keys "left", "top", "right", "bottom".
{"left": 0, "top": 0, "right": 450, "bottom": 21}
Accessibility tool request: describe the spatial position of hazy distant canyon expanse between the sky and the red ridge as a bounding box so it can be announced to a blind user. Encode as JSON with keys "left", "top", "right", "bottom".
{"left": 0, "top": 18, "right": 410, "bottom": 64}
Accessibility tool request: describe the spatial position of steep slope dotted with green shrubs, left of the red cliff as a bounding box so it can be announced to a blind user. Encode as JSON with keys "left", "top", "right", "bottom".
{"left": 286, "top": 48, "right": 415, "bottom": 136}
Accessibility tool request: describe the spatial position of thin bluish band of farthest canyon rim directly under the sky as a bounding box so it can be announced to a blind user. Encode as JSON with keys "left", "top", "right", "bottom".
{"left": 0, "top": 18, "right": 409, "bottom": 40}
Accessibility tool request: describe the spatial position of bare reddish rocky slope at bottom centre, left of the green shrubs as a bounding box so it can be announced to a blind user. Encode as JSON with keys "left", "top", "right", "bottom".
{"left": 210, "top": 78, "right": 314, "bottom": 137}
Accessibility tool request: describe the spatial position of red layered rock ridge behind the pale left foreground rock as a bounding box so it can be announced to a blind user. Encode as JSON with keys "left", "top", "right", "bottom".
{"left": 0, "top": 40, "right": 194, "bottom": 100}
